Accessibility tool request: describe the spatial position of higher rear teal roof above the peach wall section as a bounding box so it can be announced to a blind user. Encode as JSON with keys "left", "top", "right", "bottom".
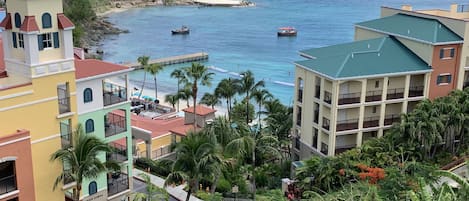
{"left": 356, "top": 14, "right": 463, "bottom": 44}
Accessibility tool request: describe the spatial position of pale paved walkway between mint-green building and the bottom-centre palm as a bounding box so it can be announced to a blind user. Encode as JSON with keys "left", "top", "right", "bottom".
{"left": 133, "top": 168, "right": 202, "bottom": 201}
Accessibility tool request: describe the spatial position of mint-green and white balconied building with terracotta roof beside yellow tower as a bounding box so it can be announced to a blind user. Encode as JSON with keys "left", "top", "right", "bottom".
{"left": 75, "top": 54, "right": 133, "bottom": 201}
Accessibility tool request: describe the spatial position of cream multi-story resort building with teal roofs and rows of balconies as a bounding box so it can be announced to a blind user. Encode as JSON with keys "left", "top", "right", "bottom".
{"left": 293, "top": 2, "right": 469, "bottom": 160}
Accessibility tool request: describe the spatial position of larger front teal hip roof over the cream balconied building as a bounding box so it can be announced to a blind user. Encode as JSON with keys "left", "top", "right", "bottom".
{"left": 295, "top": 36, "right": 431, "bottom": 79}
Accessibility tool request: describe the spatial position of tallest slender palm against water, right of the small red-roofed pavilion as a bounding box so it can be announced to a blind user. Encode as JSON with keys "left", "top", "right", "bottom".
{"left": 237, "top": 70, "right": 264, "bottom": 124}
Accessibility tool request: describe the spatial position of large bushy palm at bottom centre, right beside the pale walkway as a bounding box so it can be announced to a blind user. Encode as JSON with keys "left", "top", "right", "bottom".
{"left": 165, "top": 132, "right": 221, "bottom": 201}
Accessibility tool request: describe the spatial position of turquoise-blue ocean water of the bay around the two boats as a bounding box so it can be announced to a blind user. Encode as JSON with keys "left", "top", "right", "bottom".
{"left": 101, "top": 0, "right": 455, "bottom": 105}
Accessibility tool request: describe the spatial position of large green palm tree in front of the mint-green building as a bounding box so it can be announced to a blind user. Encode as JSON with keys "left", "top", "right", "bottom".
{"left": 50, "top": 124, "right": 120, "bottom": 201}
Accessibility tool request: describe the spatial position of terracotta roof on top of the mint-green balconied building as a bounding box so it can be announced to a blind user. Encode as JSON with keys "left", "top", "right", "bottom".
{"left": 75, "top": 59, "right": 129, "bottom": 79}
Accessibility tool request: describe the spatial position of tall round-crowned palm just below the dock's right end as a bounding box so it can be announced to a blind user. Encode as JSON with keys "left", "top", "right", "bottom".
{"left": 184, "top": 63, "right": 214, "bottom": 130}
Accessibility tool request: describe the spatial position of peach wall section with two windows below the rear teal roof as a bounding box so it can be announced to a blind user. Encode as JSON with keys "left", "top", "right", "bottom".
{"left": 428, "top": 45, "right": 461, "bottom": 99}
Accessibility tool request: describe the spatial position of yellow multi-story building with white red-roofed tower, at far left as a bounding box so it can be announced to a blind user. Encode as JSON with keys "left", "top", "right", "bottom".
{"left": 0, "top": 0, "right": 77, "bottom": 201}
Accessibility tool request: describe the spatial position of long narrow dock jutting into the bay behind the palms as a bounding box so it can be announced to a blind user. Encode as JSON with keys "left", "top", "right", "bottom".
{"left": 124, "top": 52, "right": 208, "bottom": 69}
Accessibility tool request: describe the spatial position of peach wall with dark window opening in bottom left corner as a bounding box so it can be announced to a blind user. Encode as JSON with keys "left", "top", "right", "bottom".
{"left": 0, "top": 130, "right": 36, "bottom": 201}
